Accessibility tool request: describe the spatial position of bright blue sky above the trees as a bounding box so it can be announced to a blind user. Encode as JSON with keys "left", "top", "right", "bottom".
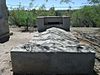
{"left": 6, "top": 0, "right": 88, "bottom": 10}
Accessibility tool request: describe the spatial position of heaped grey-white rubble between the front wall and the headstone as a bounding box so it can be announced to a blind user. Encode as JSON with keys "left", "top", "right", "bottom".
{"left": 15, "top": 27, "right": 93, "bottom": 52}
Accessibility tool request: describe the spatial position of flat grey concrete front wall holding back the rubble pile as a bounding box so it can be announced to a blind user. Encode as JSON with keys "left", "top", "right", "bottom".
{"left": 11, "top": 51, "right": 95, "bottom": 74}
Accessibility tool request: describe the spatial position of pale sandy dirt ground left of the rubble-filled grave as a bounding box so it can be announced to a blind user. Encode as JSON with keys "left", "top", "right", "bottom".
{"left": 0, "top": 28, "right": 32, "bottom": 75}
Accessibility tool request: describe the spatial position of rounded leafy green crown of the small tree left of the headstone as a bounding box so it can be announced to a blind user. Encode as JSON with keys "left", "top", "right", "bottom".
{"left": 10, "top": 10, "right": 36, "bottom": 27}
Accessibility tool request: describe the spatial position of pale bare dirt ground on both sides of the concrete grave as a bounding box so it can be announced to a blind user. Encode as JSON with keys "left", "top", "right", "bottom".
{"left": 0, "top": 28, "right": 100, "bottom": 75}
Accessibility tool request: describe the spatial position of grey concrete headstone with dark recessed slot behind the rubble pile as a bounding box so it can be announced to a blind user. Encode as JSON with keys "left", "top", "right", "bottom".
{"left": 37, "top": 16, "right": 70, "bottom": 32}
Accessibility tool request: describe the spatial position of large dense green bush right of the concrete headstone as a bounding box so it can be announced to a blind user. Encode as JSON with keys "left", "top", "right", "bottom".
{"left": 72, "top": 5, "right": 100, "bottom": 27}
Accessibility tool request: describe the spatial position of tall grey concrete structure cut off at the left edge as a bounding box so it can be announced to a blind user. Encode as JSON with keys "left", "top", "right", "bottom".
{"left": 0, "top": 0, "right": 9, "bottom": 43}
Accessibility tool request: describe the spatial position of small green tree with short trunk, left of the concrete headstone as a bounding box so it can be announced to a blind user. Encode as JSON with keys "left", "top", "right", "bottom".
{"left": 9, "top": 0, "right": 36, "bottom": 31}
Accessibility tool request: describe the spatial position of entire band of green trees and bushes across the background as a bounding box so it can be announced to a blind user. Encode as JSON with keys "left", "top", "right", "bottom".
{"left": 9, "top": 0, "right": 100, "bottom": 30}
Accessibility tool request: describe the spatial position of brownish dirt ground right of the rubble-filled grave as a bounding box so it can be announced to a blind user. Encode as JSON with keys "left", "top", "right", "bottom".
{"left": 71, "top": 27, "right": 100, "bottom": 75}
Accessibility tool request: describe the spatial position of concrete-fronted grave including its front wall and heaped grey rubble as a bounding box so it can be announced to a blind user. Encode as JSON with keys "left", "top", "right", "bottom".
{"left": 11, "top": 28, "right": 95, "bottom": 74}
